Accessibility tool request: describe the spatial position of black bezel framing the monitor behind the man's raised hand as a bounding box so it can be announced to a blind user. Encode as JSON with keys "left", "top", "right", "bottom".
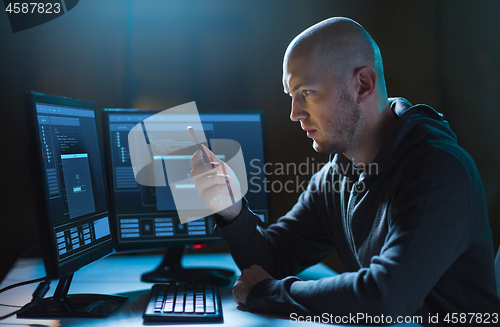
{"left": 101, "top": 108, "right": 269, "bottom": 252}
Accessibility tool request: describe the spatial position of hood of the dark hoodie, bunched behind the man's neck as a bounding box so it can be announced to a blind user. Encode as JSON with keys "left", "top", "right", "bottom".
{"left": 333, "top": 98, "right": 457, "bottom": 178}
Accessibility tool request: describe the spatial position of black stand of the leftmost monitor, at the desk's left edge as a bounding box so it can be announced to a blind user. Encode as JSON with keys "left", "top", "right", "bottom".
{"left": 17, "top": 274, "right": 128, "bottom": 318}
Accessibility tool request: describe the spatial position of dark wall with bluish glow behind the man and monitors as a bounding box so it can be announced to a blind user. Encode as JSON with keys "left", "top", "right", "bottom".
{"left": 0, "top": 0, "right": 500, "bottom": 278}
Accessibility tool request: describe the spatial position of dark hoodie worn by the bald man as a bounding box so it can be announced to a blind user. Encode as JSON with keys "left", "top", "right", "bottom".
{"left": 217, "top": 98, "right": 500, "bottom": 326}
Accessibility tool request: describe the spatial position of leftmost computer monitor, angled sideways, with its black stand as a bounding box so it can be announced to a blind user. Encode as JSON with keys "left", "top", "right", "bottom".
{"left": 18, "top": 92, "right": 126, "bottom": 318}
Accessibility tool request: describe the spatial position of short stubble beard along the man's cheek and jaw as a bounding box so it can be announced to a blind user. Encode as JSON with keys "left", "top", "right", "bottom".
{"left": 313, "top": 90, "right": 360, "bottom": 154}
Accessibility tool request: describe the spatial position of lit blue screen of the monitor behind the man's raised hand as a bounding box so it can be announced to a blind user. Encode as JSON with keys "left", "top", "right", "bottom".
{"left": 107, "top": 111, "right": 267, "bottom": 244}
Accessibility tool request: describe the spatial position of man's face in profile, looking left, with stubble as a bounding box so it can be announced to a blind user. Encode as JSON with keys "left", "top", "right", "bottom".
{"left": 283, "top": 55, "right": 360, "bottom": 154}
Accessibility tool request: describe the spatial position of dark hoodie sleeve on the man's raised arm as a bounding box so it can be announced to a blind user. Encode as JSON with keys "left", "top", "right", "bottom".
{"left": 216, "top": 167, "right": 334, "bottom": 278}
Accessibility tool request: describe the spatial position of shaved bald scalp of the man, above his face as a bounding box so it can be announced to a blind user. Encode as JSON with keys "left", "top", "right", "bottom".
{"left": 283, "top": 17, "right": 387, "bottom": 97}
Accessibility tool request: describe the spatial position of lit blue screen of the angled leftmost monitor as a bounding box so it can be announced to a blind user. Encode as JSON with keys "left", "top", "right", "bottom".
{"left": 36, "top": 103, "right": 111, "bottom": 263}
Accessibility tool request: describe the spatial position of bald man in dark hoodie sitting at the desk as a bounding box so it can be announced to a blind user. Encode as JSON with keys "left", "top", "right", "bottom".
{"left": 191, "top": 18, "right": 500, "bottom": 325}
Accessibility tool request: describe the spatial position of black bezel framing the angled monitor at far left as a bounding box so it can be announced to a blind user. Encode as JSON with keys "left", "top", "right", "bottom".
{"left": 24, "top": 91, "right": 113, "bottom": 279}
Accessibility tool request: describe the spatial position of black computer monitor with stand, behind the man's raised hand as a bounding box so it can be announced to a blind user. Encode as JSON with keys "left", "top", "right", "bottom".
{"left": 102, "top": 109, "right": 267, "bottom": 285}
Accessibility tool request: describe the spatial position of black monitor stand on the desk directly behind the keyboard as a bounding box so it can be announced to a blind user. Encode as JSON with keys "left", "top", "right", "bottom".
{"left": 141, "top": 246, "right": 234, "bottom": 287}
